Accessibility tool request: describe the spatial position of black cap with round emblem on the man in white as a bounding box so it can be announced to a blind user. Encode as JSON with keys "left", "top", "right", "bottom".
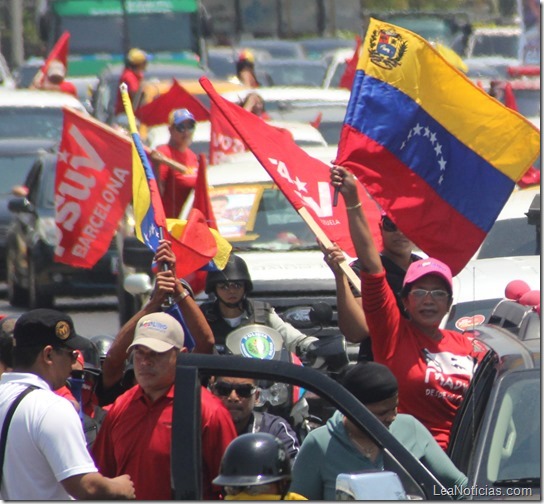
{"left": 13, "top": 308, "right": 85, "bottom": 350}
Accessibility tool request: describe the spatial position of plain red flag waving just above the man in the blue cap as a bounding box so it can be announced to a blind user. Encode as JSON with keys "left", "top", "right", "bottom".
{"left": 134, "top": 79, "right": 210, "bottom": 126}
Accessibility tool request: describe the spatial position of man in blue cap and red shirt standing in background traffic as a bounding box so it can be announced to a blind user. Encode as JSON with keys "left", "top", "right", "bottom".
{"left": 151, "top": 109, "right": 198, "bottom": 219}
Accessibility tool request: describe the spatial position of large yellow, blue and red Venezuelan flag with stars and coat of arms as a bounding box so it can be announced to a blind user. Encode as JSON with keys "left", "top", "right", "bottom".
{"left": 335, "top": 19, "right": 540, "bottom": 274}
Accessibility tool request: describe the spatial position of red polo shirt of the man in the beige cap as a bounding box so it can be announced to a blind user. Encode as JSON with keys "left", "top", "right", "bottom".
{"left": 92, "top": 385, "right": 236, "bottom": 500}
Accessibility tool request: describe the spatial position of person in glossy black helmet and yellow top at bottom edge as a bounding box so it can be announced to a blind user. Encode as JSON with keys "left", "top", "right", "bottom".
{"left": 213, "top": 432, "right": 306, "bottom": 500}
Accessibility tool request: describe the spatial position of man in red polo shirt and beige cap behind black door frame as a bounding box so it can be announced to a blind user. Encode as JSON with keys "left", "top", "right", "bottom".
{"left": 92, "top": 312, "right": 236, "bottom": 500}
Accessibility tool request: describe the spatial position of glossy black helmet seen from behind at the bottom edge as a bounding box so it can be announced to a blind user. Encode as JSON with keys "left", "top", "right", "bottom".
{"left": 213, "top": 432, "right": 291, "bottom": 486}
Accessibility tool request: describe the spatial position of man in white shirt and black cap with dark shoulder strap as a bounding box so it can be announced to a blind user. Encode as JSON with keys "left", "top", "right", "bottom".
{"left": 0, "top": 309, "right": 135, "bottom": 500}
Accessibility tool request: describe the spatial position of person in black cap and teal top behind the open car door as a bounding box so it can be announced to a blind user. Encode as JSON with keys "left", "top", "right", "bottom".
{"left": 290, "top": 361, "right": 468, "bottom": 500}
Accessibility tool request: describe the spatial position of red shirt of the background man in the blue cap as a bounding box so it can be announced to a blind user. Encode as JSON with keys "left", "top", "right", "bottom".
{"left": 157, "top": 145, "right": 198, "bottom": 219}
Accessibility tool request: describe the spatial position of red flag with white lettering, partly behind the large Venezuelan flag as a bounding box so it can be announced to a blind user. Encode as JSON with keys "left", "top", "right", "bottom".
{"left": 200, "top": 77, "right": 381, "bottom": 257}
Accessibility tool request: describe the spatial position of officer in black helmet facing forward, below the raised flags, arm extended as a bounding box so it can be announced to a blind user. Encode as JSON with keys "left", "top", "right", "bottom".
{"left": 200, "top": 254, "right": 317, "bottom": 353}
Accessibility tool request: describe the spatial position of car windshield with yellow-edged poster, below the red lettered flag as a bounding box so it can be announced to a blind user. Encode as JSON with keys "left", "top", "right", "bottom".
{"left": 210, "top": 184, "right": 318, "bottom": 251}
